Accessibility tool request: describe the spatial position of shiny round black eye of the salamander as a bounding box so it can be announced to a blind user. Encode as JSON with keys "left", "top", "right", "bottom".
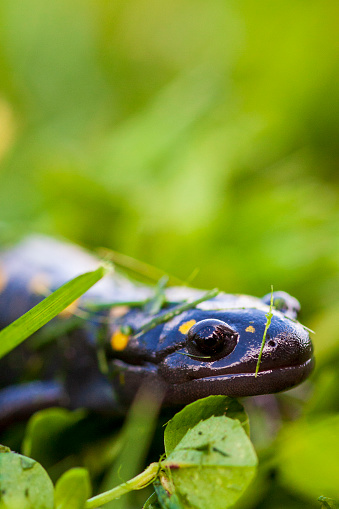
{"left": 187, "top": 319, "right": 239, "bottom": 355}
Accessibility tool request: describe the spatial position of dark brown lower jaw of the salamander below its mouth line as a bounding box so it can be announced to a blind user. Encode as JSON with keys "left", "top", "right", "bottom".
{"left": 166, "top": 357, "right": 314, "bottom": 404}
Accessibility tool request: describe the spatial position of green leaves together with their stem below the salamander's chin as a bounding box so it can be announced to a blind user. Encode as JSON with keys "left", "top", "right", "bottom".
{"left": 86, "top": 396, "right": 257, "bottom": 509}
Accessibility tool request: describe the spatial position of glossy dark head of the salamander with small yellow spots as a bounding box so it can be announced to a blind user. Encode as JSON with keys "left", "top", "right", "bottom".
{"left": 107, "top": 292, "right": 314, "bottom": 404}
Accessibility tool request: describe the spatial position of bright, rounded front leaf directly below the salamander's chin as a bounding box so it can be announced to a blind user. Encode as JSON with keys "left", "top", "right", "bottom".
{"left": 164, "top": 416, "right": 257, "bottom": 509}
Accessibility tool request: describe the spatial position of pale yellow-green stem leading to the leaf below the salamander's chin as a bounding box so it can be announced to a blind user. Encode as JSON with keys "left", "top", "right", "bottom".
{"left": 85, "top": 463, "right": 159, "bottom": 509}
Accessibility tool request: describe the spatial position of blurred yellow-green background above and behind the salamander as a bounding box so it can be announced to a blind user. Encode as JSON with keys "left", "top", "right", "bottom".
{"left": 0, "top": 0, "right": 339, "bottom": 507}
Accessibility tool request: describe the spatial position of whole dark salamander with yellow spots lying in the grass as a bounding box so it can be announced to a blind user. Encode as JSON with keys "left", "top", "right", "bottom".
{"left": 0, "top": 237, "right": 314, "bottom": 427}
